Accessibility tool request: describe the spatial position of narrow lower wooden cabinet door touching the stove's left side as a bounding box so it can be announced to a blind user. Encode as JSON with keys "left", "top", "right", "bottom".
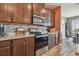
{"left": 27, "top": 37, "right": 35, "bottom": 56}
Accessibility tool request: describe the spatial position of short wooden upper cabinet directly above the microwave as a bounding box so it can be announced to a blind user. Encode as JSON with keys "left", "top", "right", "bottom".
{"left": 33, "top": 3, "right": 49, "bottom": 18}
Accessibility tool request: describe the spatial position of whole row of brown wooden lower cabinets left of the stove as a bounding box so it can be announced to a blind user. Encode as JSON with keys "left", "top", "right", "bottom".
{"left": 0, "top": 37, "right": 35, "bottom": 56}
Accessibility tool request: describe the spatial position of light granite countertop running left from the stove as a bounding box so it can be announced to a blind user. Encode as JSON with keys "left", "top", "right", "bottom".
{"left": 0, "top": 34, "right": 35, "bottom": 41}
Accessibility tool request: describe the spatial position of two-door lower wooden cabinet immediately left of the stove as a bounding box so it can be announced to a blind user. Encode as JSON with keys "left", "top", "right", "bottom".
{"left": 12, "top": 37, "right": 35, "bottom": 56}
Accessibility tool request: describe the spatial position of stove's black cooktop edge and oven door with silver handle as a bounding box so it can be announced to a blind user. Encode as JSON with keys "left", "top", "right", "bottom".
{"left": 35, "top": 32, "right": 48, "bottom": 50}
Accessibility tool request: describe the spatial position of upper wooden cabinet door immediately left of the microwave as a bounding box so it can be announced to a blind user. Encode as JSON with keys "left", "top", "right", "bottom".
{"left": 23, "top": 3, "right": 32, "bottom": 24}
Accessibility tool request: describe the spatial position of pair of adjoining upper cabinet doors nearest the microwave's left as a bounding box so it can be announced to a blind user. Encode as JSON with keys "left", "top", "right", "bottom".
{"left": 12, "top": 3, "right": 32, "bottom": 24}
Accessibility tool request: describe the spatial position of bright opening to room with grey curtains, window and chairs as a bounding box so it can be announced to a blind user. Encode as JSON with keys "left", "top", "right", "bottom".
{"left": 62, "top": 16, "right": 79, "bottom": 55}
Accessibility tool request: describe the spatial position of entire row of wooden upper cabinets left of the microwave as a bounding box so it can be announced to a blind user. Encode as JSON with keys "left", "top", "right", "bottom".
{"left": 0, "top": 3, "right": 32, "bottom": 24}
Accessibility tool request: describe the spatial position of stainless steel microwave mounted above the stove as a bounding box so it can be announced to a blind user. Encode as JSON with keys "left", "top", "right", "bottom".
{"left": 33, "top": 15, "right": 45, "bottom": 25}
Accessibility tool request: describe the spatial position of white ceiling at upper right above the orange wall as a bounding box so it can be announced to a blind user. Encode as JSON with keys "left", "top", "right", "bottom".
{"left": 45, "top": 3, "right": 79, "bottom": 18}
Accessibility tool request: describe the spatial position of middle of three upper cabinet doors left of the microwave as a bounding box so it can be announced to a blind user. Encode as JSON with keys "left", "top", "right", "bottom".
{"left": 12, "top": 3, "right": 23, "bottom": 23}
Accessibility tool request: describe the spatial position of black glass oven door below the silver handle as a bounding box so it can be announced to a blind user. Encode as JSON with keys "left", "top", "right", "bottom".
{"left": 36, "top": 36, "right": 48, "bottom": 50}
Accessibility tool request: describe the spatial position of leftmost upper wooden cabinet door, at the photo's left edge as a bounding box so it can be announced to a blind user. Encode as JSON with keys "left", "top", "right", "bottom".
{"left": 0, "top": 3, "right": 11, "bottom": 22}
